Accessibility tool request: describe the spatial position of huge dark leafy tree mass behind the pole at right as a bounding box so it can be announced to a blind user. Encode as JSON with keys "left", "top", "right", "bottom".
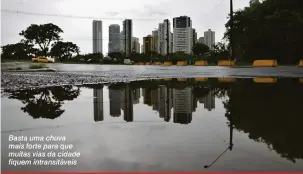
{"left": 224, "top": 0, "right": 303, "bottom": 63}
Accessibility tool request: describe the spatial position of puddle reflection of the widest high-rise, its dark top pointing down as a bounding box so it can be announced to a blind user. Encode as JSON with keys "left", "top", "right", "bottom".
{"left": 173, "top": 87, "right": 193, "bottom": 124}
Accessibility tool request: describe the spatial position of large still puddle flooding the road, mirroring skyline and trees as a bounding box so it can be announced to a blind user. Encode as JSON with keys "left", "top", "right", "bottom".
{"left": 1, "top": 77, "right": 303, "bottom": 172}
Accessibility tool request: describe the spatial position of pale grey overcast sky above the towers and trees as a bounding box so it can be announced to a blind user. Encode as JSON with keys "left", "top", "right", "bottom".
{"left": 1, "top": 0, "right": 249, "bottom": 53}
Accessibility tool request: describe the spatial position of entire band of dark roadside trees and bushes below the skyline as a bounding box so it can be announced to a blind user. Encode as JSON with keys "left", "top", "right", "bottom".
{"left": 1, "top": 0, "right": 303, "bottom": 65}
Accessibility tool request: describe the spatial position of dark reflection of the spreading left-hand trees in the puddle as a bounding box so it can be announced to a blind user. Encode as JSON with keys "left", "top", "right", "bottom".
{"left": 6, "top": 86, "right": 80, "bottom": 119}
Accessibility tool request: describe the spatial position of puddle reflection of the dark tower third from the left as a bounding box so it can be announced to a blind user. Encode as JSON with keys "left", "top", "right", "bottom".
{"left": 122, "top": 85, "right": 134, "bottom": 122}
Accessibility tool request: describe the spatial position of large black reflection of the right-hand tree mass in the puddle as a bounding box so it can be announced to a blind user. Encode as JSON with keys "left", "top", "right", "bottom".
{"left": 224, "top": 80, "right": 303, "bottom": 162}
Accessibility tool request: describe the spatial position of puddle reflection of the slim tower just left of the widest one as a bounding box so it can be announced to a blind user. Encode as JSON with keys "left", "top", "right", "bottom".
{"left": 158, "top": 85, "right": 172, "bottom": 121}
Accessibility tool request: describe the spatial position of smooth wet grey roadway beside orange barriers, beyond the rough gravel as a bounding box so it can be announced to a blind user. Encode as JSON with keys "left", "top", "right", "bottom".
{"left": 49, "top": 64, "right": 303, "bottom": 77}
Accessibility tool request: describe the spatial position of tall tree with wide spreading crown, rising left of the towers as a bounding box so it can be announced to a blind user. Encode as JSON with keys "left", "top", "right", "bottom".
{"left": 19, "top": 23, "right": 63, "bottom": 56}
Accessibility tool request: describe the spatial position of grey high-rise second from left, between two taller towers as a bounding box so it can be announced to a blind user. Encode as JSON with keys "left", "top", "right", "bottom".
{"left": 108, "top": 24, "right": 121, "bottom": 53}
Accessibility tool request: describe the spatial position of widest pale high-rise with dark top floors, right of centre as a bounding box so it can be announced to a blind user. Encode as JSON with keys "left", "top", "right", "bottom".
{"left": 173, "top": 16, "right": 193, "bottom": 54}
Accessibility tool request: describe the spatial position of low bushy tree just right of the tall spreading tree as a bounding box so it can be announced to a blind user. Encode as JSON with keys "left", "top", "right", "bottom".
{"left": 50, "top": 41, "right": 80, "bottom": 61}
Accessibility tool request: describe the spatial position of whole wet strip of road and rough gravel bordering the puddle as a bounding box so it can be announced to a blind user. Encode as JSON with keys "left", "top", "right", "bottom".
{"left": 1, "top": 63, "right": 303, "bottom": 89}
